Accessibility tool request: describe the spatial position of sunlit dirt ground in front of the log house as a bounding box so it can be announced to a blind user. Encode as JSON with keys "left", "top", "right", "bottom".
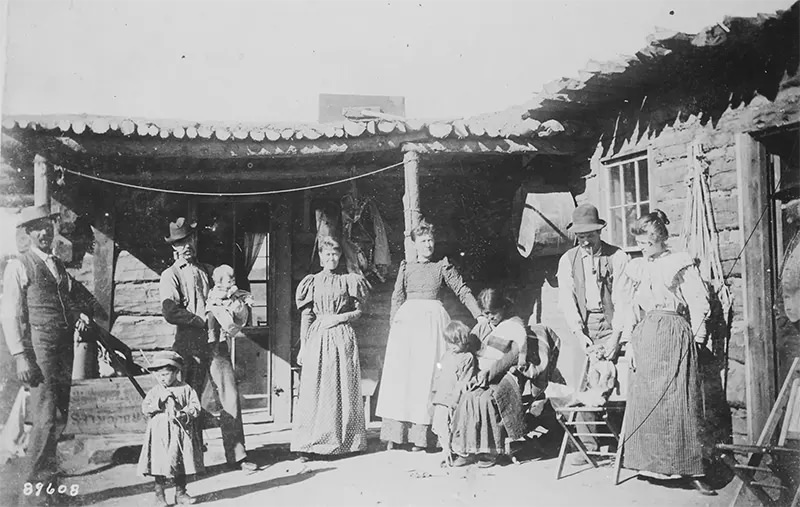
{"left": 0, "top": 424, "right": 744, "bottom": 507}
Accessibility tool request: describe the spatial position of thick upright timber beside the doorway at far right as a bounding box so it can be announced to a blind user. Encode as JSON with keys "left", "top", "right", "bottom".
{"left": 736, "top": 133, "right": 775, "bottom": 442}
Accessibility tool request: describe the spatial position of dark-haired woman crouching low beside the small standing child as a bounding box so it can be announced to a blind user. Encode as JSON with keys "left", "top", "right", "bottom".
{"left": 451, "top": 289, "right": 527, "bottom": 467}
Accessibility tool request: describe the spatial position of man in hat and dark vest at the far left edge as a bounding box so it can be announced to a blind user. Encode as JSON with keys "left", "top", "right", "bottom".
{"left": 0, "top": 205, "right": 91, "bottom": 504}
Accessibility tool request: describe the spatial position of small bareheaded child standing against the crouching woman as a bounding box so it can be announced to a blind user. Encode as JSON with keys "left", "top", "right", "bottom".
{"left": 431, "top": 320, "right": 478, "bottom": 465}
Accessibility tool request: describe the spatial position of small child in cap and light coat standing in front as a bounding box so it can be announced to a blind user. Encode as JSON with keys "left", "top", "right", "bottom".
{"left": 137, "top": 350, "right": 204, "bottom": 506}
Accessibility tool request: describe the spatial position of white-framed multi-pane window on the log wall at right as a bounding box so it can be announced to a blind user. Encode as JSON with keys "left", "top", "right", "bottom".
{"left": 604, "top": 153, "right": 650, "bottom": 250}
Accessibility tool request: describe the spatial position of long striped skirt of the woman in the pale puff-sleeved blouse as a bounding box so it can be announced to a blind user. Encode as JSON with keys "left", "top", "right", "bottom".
{"left": 623, "top": 311, "right": 703, "bottom": 475}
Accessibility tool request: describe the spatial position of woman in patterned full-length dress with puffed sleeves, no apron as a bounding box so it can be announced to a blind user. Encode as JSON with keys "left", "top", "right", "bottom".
{"left": 291, "top": 238, "right": 369, "bottom": 460}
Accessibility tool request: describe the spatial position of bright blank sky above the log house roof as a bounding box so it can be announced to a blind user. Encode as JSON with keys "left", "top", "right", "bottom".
{"left": 0, "top": 0, "right": 792, "bottom": 121}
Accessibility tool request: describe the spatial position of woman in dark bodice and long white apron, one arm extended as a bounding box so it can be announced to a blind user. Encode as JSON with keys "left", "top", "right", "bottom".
{"left": 375, "top": 220, "right": 480, "bottom": 451}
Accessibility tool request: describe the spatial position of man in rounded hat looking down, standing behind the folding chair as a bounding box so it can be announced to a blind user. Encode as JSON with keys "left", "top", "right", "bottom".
{"left": 556, "top": 204, "right": 628, "bottom": 464}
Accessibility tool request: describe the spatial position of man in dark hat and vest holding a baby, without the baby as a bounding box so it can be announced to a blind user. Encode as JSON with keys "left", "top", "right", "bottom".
{"left": 159, "top": 217, "right": 257, "bottom": 472}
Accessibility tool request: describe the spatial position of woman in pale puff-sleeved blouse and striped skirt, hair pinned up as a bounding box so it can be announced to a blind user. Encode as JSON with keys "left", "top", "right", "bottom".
{"left": 623, "top": 210, "right": 716, "bottom": 495}
